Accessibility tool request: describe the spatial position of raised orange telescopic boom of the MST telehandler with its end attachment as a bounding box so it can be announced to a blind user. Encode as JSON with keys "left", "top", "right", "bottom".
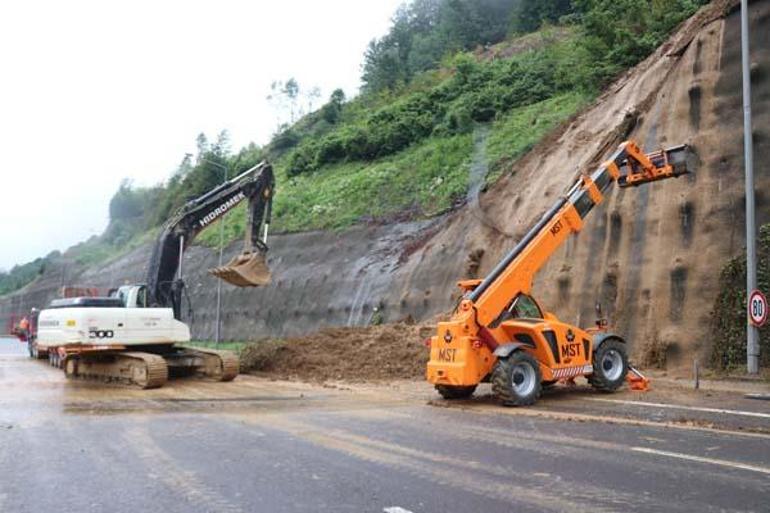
{"left": 461, "top": 141, "right": 687, "bottom": 327}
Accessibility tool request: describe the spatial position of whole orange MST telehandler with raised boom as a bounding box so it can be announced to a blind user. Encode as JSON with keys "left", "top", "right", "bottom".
{"left": 427, "top": 141, "right": 688, "bottom": 406}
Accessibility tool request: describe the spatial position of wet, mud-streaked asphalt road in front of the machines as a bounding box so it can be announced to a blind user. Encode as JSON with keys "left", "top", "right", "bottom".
{"left": 0, "top": 339, "right": 770, "bottom": 513}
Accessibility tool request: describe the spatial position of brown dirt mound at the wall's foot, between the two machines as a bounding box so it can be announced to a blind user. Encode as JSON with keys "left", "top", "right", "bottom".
{"left": 241, "top": 323, "right": 435, "bottom": 382}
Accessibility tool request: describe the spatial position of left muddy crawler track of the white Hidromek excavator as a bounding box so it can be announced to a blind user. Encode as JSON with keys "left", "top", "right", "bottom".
{"left": 64, "top": 352, "right": 168, "bottom": 389}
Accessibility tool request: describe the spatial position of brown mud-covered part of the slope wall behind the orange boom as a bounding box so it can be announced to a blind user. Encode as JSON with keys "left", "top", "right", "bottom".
{"left": 420, "top": 1, "right": 770, "bottom": 366}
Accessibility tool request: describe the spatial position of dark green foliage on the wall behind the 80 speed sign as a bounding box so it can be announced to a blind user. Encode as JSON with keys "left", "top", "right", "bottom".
{"left": 711, "top": 224, "right": 770, "bottom": 371}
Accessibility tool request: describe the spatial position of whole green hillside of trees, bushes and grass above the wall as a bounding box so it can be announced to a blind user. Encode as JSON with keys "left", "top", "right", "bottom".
{"left": 0, "top": 0, "right": 707, "bottom": 295}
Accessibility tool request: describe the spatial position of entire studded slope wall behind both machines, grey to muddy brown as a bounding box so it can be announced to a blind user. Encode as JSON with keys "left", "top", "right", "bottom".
{"left": 0, "top": 1, "right": 770, "bottom": 366}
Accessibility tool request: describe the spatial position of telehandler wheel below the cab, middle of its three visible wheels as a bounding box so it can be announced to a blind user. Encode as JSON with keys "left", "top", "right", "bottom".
{"left": 492, "top": 351, "right": 543, "bottom": 406}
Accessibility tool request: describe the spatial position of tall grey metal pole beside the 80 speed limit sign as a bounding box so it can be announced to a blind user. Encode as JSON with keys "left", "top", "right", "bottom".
{"left": 741, "top": 0, "right": 759, "bottom": 374}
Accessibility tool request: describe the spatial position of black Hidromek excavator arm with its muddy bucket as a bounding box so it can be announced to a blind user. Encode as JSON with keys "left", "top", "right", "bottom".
{"left": 146, "top": 162, "right": 275, "bottom": 319}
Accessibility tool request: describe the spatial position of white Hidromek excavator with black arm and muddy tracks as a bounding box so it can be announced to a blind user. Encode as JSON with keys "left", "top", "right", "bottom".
{"left": 24, "top": 162, "right": 275, "bottom": 388}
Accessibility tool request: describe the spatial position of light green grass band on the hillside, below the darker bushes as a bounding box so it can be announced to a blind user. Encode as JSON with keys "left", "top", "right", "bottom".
{"left": 197, "top": 93, "right": 591, "bottom": 247}
